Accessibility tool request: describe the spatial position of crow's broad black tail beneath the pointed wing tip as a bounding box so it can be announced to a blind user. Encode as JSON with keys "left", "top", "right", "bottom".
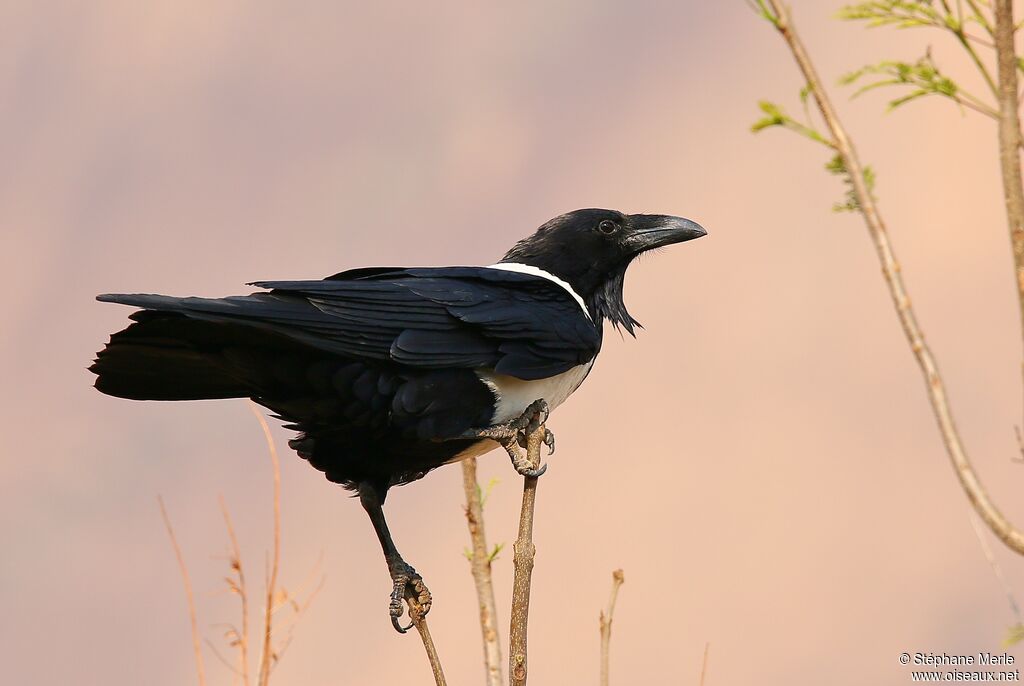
{"left": 89, "top": 310, "right": 253, "bottom": 400}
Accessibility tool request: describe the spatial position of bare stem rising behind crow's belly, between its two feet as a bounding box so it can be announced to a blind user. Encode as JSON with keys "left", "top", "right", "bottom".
{"left": 462, "top": 458, "right": 504, "bottom": 686}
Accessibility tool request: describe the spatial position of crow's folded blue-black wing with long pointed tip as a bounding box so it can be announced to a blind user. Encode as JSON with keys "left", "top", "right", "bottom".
{"left": 99, "top": 267, "right": 601, "bottom": 380}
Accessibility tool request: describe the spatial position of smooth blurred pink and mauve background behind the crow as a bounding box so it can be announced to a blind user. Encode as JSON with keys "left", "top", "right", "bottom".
{"left": 0, "top": 0, "right": 1024, "bottom": 686}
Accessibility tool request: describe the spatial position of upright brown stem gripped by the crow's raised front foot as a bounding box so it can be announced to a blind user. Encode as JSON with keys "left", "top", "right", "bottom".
{"left": 509, "top": 424, "right": 545, "bottom": 686}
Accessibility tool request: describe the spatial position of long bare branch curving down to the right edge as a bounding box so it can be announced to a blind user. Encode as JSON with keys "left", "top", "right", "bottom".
{"left": 766, "top": 0, "right": 1024, "bottom": 554}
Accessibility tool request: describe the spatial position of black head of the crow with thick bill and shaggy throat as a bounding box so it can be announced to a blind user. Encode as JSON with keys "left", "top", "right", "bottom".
{"left": 502, "top": 209, "right": 707, "bottom": 334}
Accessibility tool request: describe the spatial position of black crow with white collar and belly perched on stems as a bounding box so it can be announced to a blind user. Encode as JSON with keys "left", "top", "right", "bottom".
{"left": 89, "top": 209, "right": 706, "bottom": 633}
